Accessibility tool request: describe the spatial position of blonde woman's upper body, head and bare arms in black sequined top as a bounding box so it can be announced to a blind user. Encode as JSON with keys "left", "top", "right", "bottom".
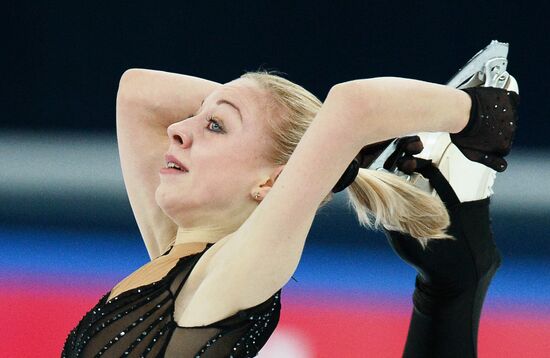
{"left": 63, "top": 69, "right": 511, "bottom": 357}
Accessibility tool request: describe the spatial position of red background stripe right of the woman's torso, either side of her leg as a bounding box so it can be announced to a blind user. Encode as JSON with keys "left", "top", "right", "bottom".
{"left": 280, "top": 304, "right": 550, "bottom": 358}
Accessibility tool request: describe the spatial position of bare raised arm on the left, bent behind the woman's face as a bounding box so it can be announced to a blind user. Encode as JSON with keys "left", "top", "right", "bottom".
{"left": 116, "top": 69, "right": 221, "bottom": 259}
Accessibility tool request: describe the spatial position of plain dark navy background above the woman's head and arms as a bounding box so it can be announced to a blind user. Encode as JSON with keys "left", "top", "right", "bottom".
{"left": 5, "top": 1, "right": 550, "bottom": 148}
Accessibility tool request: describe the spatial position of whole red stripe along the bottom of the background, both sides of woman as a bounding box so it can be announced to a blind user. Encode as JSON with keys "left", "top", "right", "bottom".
{"left": 0, "top": 285, "right": 550, "bottom": 358}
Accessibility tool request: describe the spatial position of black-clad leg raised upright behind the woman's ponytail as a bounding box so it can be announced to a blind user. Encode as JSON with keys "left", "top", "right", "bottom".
{"left": 385, "top": 161, "right": 501, "bottom": 358}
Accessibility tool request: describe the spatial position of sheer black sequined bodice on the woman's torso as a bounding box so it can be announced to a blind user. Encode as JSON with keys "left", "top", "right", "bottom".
{"left": 61, "top": 244, "right": 281, "bottom": 358}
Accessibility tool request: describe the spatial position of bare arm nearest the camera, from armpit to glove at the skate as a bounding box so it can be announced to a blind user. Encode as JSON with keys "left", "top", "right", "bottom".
{"left": 179, "top": 78, "right": 470, "bottom": 325}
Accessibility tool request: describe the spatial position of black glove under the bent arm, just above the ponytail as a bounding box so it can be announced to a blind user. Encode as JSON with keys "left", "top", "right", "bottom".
{"left": 356, "top": 136, "right": 424, "bottom": 174}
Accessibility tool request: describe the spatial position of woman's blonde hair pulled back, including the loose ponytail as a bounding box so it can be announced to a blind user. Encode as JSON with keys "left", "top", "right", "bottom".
{"left": 241, "top": 70, "right": 452, "bottom": 246}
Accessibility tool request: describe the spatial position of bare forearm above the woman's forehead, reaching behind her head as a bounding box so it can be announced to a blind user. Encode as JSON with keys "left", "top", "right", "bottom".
{"left": 117, "top": 69, "right": 221, "bottom": 128}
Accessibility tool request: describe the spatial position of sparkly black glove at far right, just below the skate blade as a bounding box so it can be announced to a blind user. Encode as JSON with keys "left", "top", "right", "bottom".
{"left": 450, "top": 87, "right": 519, "bottom": 172}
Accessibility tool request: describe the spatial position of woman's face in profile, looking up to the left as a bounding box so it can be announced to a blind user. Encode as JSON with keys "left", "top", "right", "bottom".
{"left": 155, "top": 79, "right": 275, "bottom": 226}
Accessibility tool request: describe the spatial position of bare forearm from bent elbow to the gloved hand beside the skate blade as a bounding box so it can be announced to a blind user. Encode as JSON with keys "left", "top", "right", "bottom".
{"left": 331, "top": 77, "right": 471, "bottom": 145}
